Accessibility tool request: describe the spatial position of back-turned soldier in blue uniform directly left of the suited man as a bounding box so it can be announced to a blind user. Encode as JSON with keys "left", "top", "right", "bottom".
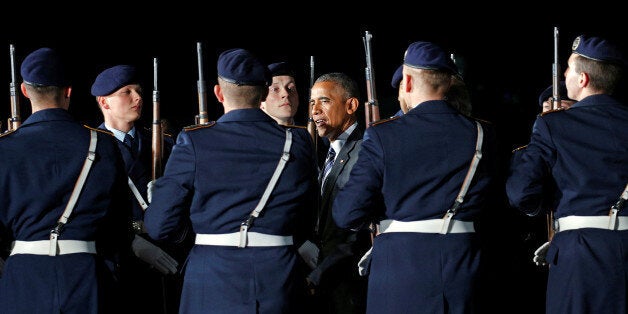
{"left": 144, "top": 49, "right": 317, "bottom": 313}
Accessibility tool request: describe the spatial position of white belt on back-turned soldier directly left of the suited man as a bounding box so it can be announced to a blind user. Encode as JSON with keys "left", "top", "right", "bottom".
{"left": 195, "top": 232, "right": 293, "bottom": 246}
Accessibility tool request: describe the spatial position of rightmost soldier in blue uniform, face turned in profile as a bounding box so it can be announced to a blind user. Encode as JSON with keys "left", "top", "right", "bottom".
{"left": 506, "top": 35, "right": 628, "bottom": 314}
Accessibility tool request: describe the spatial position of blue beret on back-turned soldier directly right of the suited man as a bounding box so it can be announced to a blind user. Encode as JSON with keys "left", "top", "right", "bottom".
{"left": 403, "top": 41, "right": 458, "bottom": 74}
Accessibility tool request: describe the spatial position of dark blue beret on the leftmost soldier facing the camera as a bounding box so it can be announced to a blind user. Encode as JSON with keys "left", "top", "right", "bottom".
{"left": 91, "top": 65, "right": 139, "bottom": 96}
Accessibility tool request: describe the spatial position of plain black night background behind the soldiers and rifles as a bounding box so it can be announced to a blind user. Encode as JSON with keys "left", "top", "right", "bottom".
{"left": 0, "top": 1, "right": 627, "bottom": 313}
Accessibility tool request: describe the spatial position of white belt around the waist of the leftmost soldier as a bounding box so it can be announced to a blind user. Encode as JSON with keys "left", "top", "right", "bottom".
{"left": 11, "top": 240, "right": 96, "bottom": 255}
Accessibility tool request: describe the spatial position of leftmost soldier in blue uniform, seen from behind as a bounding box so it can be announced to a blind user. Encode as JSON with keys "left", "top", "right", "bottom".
{"left": 0, "top": 48, "right": 131, "bottom": 313}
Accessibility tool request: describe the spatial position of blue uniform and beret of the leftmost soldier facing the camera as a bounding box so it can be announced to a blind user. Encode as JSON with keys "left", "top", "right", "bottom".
{"left": 91, "top": 65, "right": 186, "bottom": 314}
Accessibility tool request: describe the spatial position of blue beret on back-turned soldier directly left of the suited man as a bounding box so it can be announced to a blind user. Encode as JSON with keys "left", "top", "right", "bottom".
{"left": 218, "top": 48, "right": 272, "bottom": 86}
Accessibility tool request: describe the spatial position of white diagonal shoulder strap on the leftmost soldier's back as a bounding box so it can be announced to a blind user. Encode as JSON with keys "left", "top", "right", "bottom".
{"left": 48, "top": 130, "right": 98, "bottom": 256}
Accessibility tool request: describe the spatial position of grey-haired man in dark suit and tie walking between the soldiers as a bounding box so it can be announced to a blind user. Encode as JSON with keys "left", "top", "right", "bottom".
{"left": 307, "top": 73, "right": 370, "bottom": 313}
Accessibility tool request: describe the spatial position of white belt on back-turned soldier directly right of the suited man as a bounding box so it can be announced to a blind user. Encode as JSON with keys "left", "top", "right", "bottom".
{"left": 379, "top": 219, "right": 475, "bottom": 233}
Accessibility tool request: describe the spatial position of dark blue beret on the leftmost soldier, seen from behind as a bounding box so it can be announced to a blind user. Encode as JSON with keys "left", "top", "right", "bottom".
{"left": 20, "top": 47, "right": 70, "bottom": 87}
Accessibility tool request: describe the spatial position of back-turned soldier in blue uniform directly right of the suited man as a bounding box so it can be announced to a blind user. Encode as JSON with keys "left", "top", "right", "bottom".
{"left": 333, "top": 42, "right": 495, "bottom": 313}
